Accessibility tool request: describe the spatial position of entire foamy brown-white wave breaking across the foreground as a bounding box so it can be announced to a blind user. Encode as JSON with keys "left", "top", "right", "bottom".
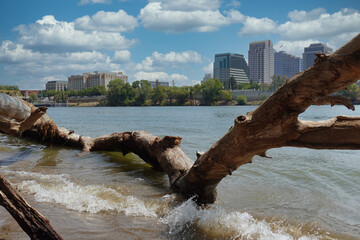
{"left": 5, "top": 170, "right": 338, "bottom": 240}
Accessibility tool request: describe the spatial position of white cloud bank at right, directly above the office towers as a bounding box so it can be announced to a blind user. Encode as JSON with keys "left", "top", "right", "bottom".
{"left": 239, "top": 8, "right": 360, "bottom": 56}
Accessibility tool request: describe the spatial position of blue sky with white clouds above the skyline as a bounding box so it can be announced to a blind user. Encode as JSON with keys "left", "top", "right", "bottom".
{"left": 0, "top": 0, "right": 360, "bottom": 90}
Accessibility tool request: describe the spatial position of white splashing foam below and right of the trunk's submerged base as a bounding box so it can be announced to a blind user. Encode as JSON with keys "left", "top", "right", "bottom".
{"left": 161, "top": 199, "right": 328, "bottom": 240}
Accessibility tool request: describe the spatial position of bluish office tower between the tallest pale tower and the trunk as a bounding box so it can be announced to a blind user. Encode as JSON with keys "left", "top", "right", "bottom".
{"left": 274, "top": 51, "right": 302, "bottom": 78}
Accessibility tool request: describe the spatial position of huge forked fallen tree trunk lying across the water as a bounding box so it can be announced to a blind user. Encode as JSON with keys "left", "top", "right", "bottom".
{"left": 0, "top": 32, "right": 360, "bottom": 237}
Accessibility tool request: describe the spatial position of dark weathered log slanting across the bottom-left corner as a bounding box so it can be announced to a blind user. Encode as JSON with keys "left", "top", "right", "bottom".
{"left": 0, "top": 175, "right": 62, "bottom": 240}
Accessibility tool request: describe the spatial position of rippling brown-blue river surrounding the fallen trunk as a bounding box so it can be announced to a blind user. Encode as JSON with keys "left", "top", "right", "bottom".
{"left": 0, "top": 106, "right": 360, "bottom": 240}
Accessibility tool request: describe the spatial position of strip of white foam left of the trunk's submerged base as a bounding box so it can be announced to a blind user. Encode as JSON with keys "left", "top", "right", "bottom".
{"left": 13, "top": 171, "right": 158, "bottom": 217}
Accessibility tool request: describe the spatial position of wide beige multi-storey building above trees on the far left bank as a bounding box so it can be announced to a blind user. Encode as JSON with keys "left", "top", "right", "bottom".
{"left": 68, "top": 71, "right": 128, "bottom": 90}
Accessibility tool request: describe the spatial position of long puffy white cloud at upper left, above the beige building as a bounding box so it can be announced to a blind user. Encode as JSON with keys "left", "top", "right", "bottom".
{"left": 15, "top": 15, "right": 136, "bottom": 52}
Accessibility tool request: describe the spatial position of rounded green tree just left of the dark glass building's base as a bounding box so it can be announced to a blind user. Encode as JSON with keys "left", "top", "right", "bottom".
{"left": 201, "top": 78, "right": 223, "bottom": 105}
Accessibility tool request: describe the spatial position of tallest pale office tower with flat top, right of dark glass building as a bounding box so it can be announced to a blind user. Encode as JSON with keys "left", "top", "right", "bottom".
{"left": 248, "top": 40, "right": 274, "bottom": 84}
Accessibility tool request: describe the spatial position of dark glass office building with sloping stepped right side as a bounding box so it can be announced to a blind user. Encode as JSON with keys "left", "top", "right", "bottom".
{"left": 214, "top": 53, "right": 249, "bottom": 87}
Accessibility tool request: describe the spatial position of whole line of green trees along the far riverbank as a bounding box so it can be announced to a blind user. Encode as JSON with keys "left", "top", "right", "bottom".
{"left": 0, "top": 75, "right": 360, "bottom": 106}
